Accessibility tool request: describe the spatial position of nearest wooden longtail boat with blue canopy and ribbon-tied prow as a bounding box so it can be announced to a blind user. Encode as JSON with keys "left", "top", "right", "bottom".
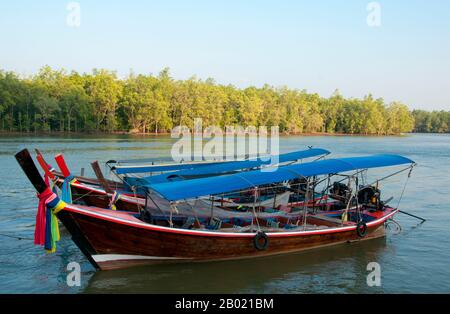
{"left": 16, "top": 150, "right": 415, "bottom": 269}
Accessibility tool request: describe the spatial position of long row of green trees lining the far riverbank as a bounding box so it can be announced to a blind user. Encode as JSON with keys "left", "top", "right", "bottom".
{"left": 0, "top": 66, "right": 432, "bottom": 135}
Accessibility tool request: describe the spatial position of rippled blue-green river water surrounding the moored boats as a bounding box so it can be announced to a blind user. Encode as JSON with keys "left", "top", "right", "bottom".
{"left": 0, "top": 135, "right": 450, "bottom": 293}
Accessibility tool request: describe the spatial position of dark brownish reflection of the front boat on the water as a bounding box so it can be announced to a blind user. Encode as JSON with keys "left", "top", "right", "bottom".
{"left": 83, "top": 238, "right": 387, "bottom": 293}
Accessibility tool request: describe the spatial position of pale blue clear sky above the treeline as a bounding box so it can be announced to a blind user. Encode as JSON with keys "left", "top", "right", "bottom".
{"left": 0, "top": 0, "right": 450, "bottom": 110}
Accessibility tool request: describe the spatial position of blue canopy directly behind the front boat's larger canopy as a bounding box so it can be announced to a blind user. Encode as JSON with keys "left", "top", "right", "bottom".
{"left": 133, "top": 148, "right": 330, "bottom": 185}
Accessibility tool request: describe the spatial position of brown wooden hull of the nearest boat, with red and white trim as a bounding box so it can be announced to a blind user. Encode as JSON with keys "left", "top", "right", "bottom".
{"left": 58, "top": 206, "right": 396, "bottom": 270}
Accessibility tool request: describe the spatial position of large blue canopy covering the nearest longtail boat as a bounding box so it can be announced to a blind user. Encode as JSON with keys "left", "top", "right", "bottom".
{"left": 147, "top": 155, "right": 414, "bottom": 201}
